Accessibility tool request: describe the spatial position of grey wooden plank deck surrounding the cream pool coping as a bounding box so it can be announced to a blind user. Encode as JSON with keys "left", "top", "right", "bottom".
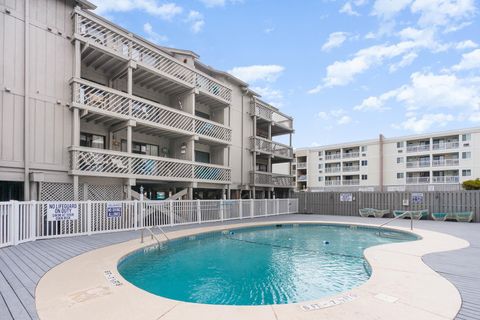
{"left": 0, "top": 214, "right": 480, "bottom": 320}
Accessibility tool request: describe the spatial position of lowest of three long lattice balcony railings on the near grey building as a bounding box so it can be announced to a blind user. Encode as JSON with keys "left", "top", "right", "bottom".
{"left": 69, "top": 147, "right": 231, "bottom": 184}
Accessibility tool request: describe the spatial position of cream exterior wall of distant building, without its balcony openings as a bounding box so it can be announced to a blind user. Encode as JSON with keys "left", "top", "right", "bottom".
{"left": 295, "top": 128, "right": 480, "bottom": 191}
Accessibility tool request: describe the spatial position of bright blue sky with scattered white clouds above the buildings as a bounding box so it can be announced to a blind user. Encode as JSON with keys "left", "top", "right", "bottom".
{"left": 92, "top": 0, "right": 480, "bottom": 147}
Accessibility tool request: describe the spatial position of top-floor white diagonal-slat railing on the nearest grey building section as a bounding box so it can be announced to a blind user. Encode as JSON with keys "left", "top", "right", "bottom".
{"left": 75, "top": 9, "right": 232, "bottom": 104}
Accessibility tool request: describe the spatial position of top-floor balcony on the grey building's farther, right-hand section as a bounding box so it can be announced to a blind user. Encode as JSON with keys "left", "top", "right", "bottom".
{"left": 250, "top": 99, "right": 293, "bottom": 135}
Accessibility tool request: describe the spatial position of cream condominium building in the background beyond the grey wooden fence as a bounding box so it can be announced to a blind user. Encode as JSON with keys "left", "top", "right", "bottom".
{"left": 292, "top": 128, "right": 480, "bottom": 191}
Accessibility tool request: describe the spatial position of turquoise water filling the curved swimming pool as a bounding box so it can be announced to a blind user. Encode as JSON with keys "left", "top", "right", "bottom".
{"left": 118, "top": 224, "right": 417, "bottom": 305}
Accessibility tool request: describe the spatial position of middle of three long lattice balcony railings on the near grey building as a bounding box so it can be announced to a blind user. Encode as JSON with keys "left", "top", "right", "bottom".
{"left": 73, "top": 79, "right": 232, "bottom": 143}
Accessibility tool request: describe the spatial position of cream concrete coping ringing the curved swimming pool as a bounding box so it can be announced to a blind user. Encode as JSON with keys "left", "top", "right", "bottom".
{"left": 36, "top": 220, "right": 469, "bottom": 320}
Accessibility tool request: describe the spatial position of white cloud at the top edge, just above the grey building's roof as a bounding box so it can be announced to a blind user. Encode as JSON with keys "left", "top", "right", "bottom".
{"left": 93, "top": 0, "right": 183, "bottom": 20}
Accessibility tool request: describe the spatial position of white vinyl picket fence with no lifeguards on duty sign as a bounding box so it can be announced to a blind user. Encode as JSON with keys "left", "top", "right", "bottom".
{"left": 0, "top": 199, "right": 298, "bottom": 247}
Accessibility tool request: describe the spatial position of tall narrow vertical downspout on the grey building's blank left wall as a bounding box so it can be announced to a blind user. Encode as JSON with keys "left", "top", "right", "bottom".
{"left": 23, "top": 0, "right": 30, "bottom": 201}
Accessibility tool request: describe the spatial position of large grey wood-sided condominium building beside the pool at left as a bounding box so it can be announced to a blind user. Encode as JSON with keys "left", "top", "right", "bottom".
{"left": 0, "top": 0, "right": 294, "bottom": 200}
